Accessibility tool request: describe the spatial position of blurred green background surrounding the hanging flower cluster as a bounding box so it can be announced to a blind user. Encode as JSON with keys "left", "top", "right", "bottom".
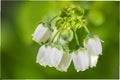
{"left": 0, "top": 1, "right": 119, "bottom": 79}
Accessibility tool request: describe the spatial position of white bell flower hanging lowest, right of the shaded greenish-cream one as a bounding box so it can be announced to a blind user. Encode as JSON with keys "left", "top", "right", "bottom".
{"left": 72, "top": 50, "right": 89, "bottom": 72}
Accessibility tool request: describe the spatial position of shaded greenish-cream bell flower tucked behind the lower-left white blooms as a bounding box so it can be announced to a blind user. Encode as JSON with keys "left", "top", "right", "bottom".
{"left": 56, "top": 53, "right": 72, "bottom": 72}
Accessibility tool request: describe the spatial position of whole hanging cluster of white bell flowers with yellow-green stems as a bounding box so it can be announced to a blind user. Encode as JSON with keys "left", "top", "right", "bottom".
{"left": 32, "top": 6, "right": 102, "bottom": 72}
